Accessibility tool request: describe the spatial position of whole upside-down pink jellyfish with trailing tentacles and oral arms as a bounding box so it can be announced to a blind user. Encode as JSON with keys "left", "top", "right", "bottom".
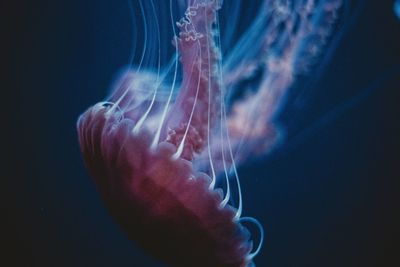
{"left": 77, "top": 0, "right": 345, "bottom": 267}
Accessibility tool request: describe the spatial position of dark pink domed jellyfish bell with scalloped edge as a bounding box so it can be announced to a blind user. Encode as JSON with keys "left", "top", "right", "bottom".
{"left": 78, "top": 103, "right": 252, "bottom": 266}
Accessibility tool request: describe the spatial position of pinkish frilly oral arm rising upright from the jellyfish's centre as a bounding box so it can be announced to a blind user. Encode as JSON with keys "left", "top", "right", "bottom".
{"left": 167, "top": 1, "right": 220, "bottom": 159}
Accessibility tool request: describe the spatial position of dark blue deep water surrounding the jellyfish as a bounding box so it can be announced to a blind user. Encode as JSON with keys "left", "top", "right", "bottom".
{"left": 0, "top": 0, "right": 400, "bottom": 267}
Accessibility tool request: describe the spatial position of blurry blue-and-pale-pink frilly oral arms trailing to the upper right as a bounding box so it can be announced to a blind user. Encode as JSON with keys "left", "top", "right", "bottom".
{"left": 195, "top": 0, "right": 345, "bottom": 174}
